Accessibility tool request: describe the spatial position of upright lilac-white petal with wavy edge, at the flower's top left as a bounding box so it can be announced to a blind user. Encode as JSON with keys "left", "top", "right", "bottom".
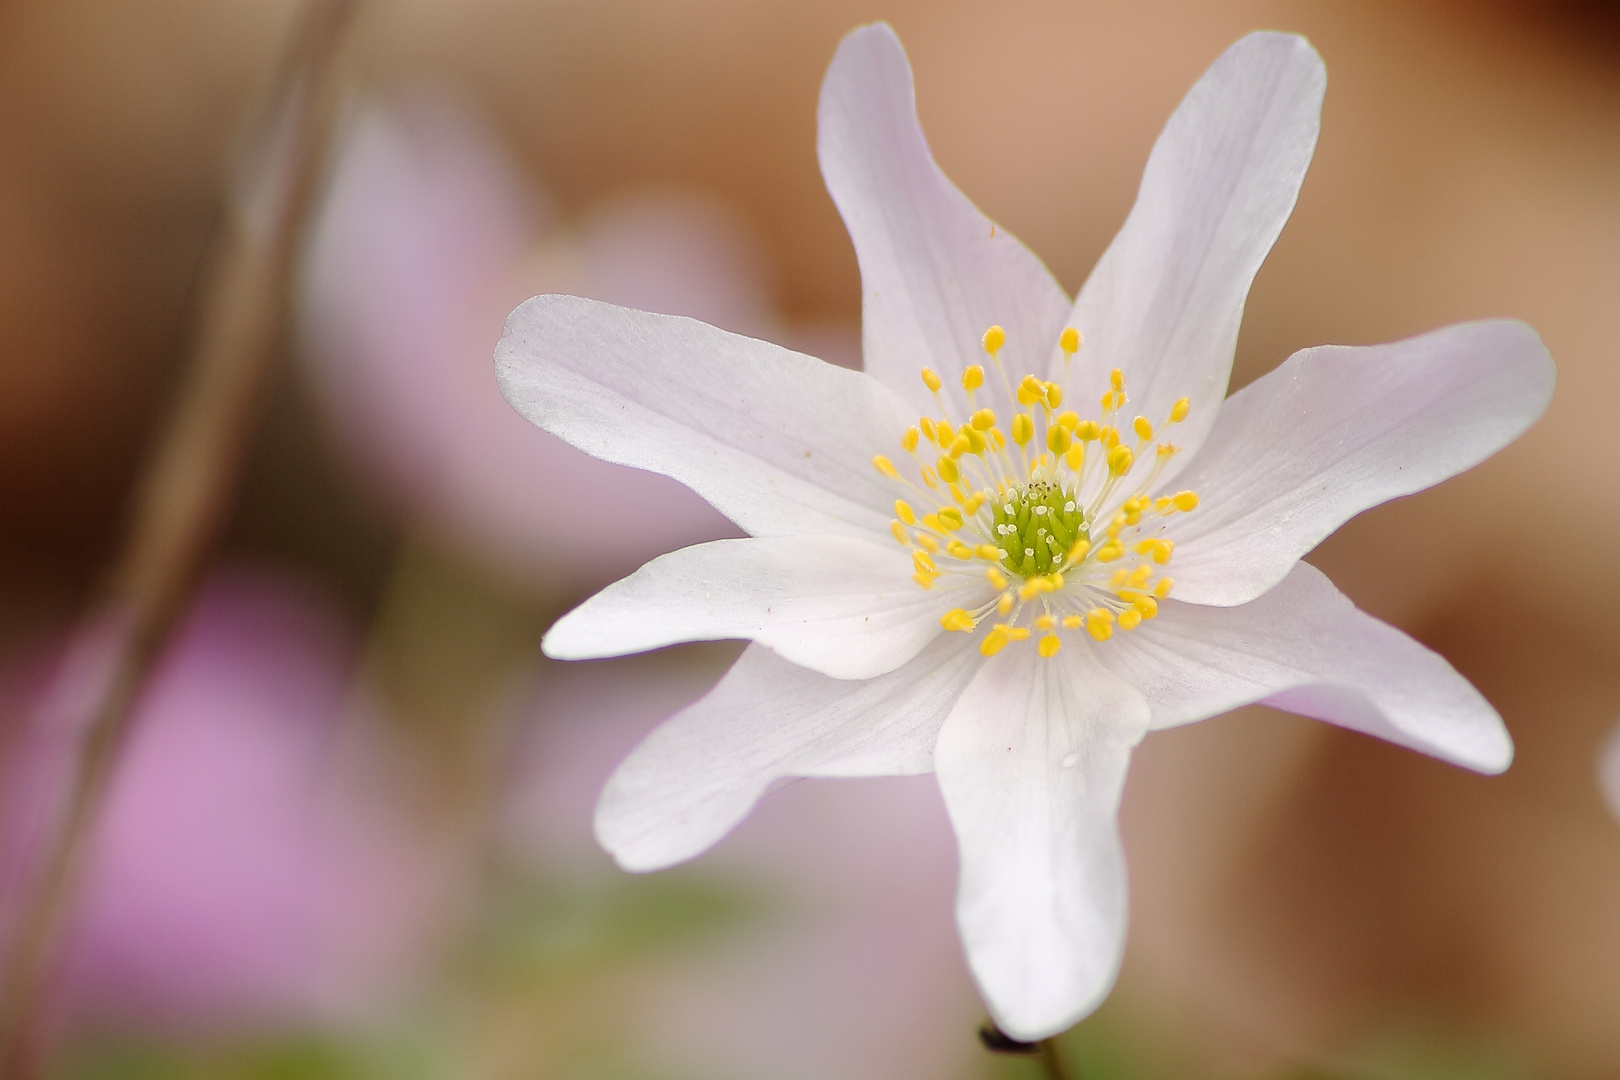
{"left": 818, "top": 23, "right": 1069, "bottom": 415}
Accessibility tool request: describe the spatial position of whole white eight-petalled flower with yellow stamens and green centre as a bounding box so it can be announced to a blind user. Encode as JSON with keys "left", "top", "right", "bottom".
{"left": 496, "top": 26, "right": 1554, "bottom": 1040}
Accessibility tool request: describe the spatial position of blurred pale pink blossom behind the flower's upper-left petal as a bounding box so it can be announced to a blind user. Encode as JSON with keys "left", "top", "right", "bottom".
{"left": 303, "top": 94, "right": 787, "bottom": 592}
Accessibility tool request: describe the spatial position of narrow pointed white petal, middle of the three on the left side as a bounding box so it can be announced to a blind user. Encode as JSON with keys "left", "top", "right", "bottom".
{"left": 541, "top": 536, "right": 988, "bottom": 678}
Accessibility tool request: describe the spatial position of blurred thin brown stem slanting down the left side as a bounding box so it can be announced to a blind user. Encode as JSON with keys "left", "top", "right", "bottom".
{"left": 0, "top": 0, "right": 358, "bottom": 1080}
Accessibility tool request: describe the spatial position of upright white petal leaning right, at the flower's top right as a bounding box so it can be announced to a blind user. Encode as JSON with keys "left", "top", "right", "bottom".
{"left": 1051, "top": 32, "right": 1327, "bottom": 469}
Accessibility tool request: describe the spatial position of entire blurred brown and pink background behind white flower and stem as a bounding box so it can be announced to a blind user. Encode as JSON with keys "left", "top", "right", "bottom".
{"left": 0, "top": 0, "right": 1620, "bottom": 1080}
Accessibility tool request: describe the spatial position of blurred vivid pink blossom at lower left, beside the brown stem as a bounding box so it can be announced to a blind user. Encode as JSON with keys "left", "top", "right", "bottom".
{"left": 3, "top": 572, "right": 446, "bottom": 1030}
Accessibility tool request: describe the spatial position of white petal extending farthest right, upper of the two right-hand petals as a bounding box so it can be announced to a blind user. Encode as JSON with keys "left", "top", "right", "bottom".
{"left": 1171, "top": 321, "right": 1555, "bottom": 606}
